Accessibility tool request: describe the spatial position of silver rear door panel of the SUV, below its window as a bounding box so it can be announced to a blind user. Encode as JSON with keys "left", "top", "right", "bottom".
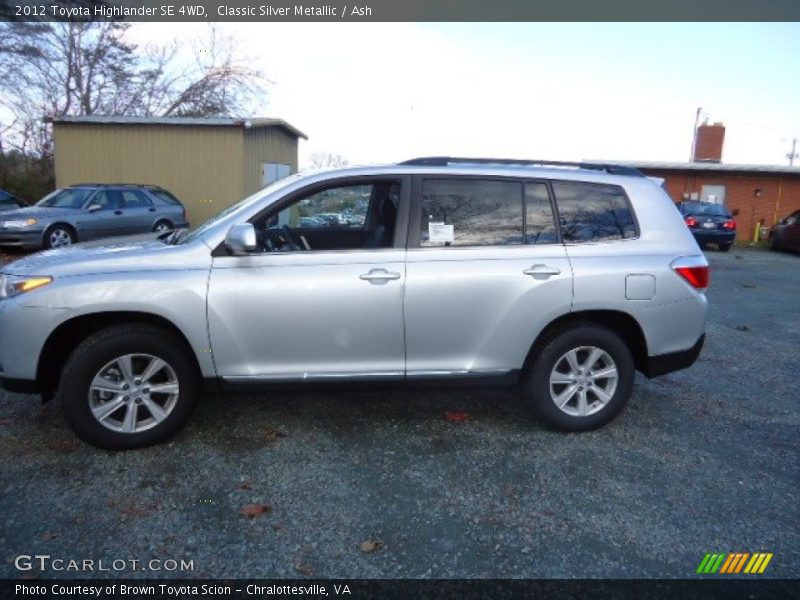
{"left": 405, "top": 244, "right": 572, "bottom": 378}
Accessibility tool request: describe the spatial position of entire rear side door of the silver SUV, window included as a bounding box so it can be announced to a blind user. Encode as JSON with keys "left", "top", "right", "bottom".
{"left": 405, "top": 175, "right": 572, "bottom": 378}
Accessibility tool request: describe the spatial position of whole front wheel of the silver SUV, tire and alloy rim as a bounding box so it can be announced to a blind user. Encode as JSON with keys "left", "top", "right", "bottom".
{"left": 60, "top": 325, "right": 199, "bottom": 450}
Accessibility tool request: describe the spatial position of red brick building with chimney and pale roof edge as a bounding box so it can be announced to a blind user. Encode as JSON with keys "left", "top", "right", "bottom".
{"left": 625, "top": 123, "right": 800, "bottom": 241}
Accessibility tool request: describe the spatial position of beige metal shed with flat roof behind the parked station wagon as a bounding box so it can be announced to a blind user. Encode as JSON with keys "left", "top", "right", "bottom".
{"left": 52, "top": 115, "right": 307, "bottom": 225}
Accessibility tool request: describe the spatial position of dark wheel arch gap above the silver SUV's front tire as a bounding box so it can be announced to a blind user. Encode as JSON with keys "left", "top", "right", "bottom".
{"left": 36, "top": 311, "right": 201, "bottom": 402}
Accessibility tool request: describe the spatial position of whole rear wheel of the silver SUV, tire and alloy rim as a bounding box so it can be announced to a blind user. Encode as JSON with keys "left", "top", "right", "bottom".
{"left": 523, "top": 323, "right": 635, "bottom": 431}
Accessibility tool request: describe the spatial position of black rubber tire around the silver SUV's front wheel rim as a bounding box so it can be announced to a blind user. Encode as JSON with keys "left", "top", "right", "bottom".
{"left": 60, "top": 324, "right": 200, "bottom": 450}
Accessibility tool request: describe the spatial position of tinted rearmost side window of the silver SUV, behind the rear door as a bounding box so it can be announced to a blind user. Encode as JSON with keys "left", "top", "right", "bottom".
{"left": 552, "top": 181, "right": 638, "bottom": 243}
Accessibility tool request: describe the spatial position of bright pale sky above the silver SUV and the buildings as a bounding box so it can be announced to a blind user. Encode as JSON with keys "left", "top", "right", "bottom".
{"left": 131, "top": 23, "right": 800, "bottom": 166}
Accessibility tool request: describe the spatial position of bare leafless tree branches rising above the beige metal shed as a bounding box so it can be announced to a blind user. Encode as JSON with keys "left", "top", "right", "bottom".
{"left": 0, "top": 22, "right": 266, "bottom": 155}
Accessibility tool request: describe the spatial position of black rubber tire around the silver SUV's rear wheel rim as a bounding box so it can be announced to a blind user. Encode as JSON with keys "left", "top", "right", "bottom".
{"left": 522, "top": 323, "right": 635, "bottom": 431}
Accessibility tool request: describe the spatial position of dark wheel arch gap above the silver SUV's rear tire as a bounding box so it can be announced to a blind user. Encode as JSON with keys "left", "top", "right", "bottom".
{"left": 522, "top": 310, "right": 648, "bottom": 372}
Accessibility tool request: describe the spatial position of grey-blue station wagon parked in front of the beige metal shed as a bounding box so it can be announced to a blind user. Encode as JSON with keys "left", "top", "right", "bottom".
{"left": 0, "top": 183, "right": 189, "bottom": 249}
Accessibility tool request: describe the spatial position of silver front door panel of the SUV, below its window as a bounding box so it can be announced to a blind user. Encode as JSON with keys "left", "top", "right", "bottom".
{"left": 208, "top": 249, "right": 405, "bottom": 380}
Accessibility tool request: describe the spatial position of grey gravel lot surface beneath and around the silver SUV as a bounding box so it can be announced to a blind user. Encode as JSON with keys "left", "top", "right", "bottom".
{"left": 0, "top": 250, "right": 800, "bottom": 578}
